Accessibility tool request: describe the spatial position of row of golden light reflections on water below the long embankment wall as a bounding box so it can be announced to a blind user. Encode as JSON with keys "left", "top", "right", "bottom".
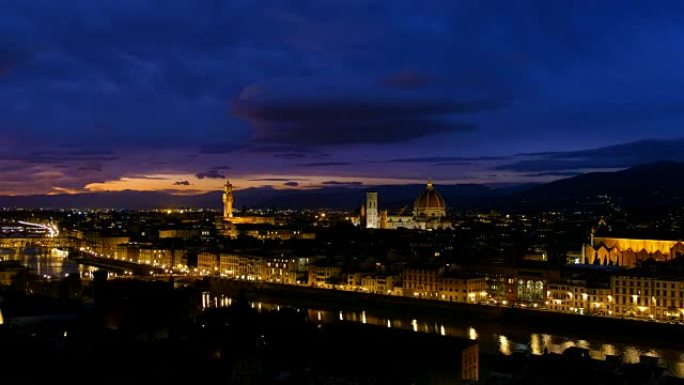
{"left": 203, "top": 293, "right": 684, "bottom": 378}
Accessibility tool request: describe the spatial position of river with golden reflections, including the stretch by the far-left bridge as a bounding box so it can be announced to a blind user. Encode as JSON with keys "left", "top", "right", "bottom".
{"left": 0, "top": 249, "right": 684, "bottom": 378}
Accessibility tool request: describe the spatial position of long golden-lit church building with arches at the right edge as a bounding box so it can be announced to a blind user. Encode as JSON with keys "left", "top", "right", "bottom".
{"left": 582, "top": 234, "right": 684, "bottom": 267}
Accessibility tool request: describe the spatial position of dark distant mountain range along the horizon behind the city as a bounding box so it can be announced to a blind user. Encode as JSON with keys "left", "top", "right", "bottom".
{"left": 0, "top": 162, "right": 684, "bottom": 211}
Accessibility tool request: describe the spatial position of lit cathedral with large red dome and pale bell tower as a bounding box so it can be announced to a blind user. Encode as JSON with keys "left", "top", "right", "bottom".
{"left": 356, "top": 180, "right": 451, "bottom": 230}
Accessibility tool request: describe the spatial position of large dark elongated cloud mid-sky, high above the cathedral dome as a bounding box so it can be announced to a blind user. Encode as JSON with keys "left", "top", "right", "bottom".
{"left": 233, "top": 95, "right": 488, "bottom": 146}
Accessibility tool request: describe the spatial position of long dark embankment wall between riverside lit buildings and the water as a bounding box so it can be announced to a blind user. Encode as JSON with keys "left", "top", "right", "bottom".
{"left": 204, "top": 278, "right": 684, "bottom": 351}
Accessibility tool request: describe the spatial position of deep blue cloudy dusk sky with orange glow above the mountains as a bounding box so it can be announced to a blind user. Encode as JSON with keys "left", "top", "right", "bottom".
{"left": 0, "top": 0, "right": 684, "bottom": 194}
